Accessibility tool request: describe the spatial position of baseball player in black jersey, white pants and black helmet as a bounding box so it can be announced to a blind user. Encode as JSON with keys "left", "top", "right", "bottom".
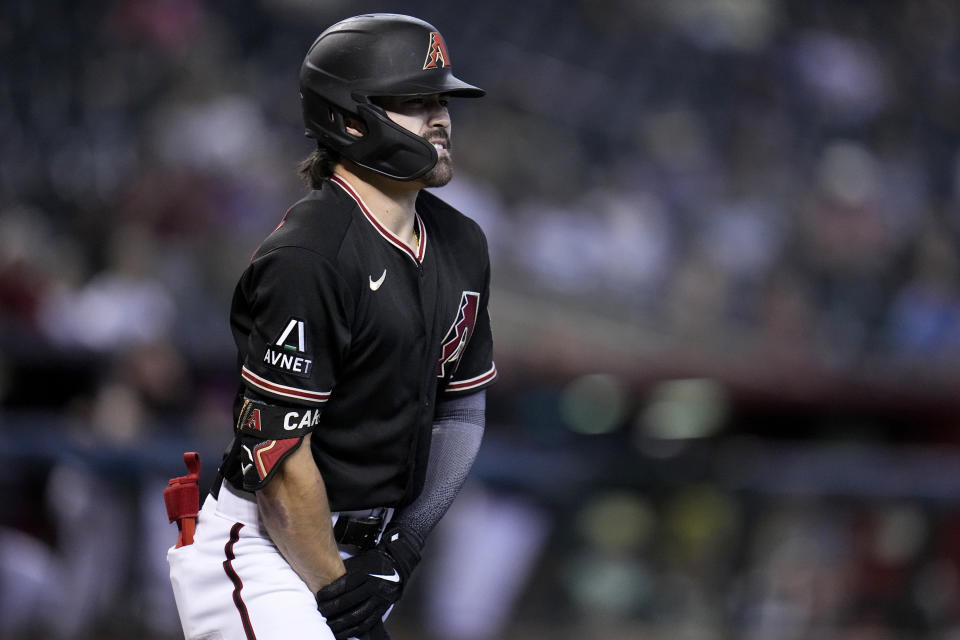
{"left": 168, "top": 14, "right": 497, "bottom": 640}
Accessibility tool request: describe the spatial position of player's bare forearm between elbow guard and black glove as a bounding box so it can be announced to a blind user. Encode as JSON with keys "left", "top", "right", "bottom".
{"left": 256, "top": 434, "right": 346, "bottom": 593}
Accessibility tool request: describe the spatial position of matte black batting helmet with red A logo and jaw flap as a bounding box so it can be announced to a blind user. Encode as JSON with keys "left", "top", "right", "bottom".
{"left": 300, "top": 13, "right": 484, "bottom": 180}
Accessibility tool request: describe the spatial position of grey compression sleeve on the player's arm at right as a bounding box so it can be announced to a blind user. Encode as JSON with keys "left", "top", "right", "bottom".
{"left": 393, "top": 390, "right": 486, "bottom": 540}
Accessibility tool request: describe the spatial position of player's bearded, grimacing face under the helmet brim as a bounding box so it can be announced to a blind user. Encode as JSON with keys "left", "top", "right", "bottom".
{"left": 377, "top": 93, "right": 453, "bottom": 187}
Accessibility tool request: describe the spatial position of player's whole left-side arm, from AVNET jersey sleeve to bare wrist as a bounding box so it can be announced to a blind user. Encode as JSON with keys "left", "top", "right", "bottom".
{"left": 234, "top": 246, "right": 352, "bottom": 592}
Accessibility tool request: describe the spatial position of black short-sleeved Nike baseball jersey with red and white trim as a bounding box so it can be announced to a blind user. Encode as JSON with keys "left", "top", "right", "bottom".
{"left": 221, "top": 176, "right": 496, "bottom": 511}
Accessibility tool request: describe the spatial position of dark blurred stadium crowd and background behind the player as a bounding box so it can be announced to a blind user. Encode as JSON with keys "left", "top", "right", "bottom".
{"left": 0, "top": 0, "right": 960, "bottom": 639}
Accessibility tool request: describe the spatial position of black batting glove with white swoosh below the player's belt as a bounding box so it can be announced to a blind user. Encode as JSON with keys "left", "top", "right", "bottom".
{"left": 317, "top": 527, "right": 423, "bottom": 640}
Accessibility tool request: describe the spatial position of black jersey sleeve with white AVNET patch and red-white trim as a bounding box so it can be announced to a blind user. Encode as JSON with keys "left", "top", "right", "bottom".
{"left": 238, "top": 247, "right": 351, "bottom": 408}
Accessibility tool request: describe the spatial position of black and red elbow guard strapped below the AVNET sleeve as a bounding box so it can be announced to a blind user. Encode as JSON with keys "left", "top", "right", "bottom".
{"left": 236, "top": 398, "right": 320, "bottom": 491}
